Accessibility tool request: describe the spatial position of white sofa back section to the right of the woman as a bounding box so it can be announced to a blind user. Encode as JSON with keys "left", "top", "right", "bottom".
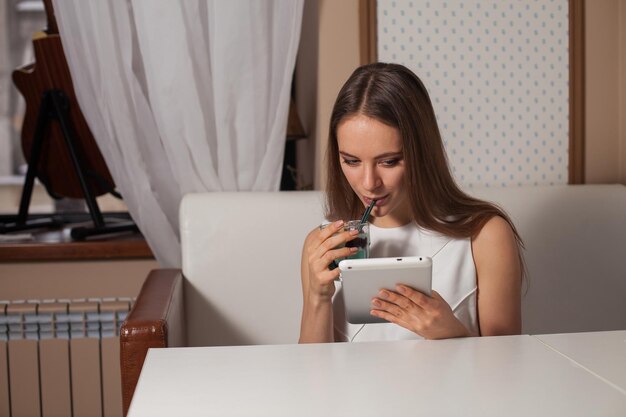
{"left": 470, "top": 185, "right": 626, "bottom": 334}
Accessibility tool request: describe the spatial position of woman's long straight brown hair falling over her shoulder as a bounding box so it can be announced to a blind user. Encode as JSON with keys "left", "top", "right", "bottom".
{"left": 326, "top": 63, "right": 524, "bottom": 264}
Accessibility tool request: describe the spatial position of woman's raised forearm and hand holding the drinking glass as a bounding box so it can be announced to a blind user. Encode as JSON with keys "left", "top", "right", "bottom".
{"left": 300, "top": 222, "right": 358, "bottom": 343}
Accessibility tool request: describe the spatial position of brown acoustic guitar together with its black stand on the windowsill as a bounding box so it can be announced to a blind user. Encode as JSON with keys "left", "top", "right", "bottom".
{"left": 0, "top": 0, "right": 139, "bottom": 240}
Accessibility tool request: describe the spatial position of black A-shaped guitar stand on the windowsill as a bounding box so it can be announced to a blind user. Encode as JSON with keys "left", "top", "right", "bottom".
{"left": 0, "top": 90, "right": 139, "bottom": 240}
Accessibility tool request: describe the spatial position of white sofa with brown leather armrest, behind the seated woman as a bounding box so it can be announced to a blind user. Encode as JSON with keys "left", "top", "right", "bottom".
{"left": 121, "top": 185, "right": 626, "bottom": 412}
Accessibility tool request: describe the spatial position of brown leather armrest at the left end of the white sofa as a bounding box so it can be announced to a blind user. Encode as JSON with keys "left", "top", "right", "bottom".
{"left": 120, "top": 269, "right": 186, "bottom": 415}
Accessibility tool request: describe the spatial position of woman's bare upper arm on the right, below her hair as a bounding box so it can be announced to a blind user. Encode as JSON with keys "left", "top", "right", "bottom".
{"left": 472, "top": 217, "right": 522, "bottom": 336}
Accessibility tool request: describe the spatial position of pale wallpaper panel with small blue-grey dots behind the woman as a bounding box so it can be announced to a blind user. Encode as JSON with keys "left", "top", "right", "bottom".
{"left": 377, "top": 0, "right": 569, "bottom": 187}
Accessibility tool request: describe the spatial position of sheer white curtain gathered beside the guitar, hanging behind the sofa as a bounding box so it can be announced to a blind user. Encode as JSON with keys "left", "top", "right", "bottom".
{"left": 54, "top": 0, "right": 303, "bottom": 267}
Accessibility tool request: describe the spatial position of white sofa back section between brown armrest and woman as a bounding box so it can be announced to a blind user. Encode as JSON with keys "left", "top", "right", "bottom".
{"left": 180, "top": 191, "right": 324, "bottom": 346}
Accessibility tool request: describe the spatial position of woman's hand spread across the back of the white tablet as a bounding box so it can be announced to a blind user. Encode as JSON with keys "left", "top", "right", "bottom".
{"left": 371, "top": 285, "right": 469, "bottom": 339}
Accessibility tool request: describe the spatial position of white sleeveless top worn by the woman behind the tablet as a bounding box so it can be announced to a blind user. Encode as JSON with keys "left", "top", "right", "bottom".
{"left": 333, "top": 223, "right": 479, "bottom": 342}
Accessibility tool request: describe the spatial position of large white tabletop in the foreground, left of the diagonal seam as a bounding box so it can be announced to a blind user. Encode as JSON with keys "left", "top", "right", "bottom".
{"left": 128, "top": 335, "right": 626, "bottom": 417}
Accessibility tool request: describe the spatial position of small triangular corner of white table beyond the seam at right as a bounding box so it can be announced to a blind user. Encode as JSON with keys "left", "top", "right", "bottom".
{"left": 535, "top": 330, "right": 626, "bottom": 395}
